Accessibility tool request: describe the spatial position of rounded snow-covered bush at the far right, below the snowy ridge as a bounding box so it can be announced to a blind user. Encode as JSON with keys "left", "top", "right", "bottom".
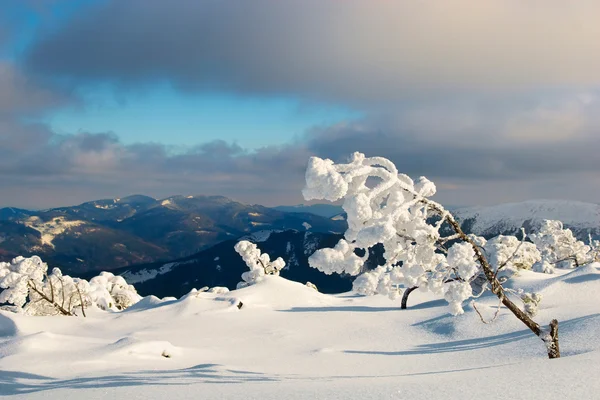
{"left": 531, "top": 220, "right": 598, "bottom": 273}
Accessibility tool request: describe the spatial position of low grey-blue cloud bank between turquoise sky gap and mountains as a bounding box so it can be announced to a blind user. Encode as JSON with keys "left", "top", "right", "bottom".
{"left": 0, "top": 91, "right": 600, "bottom": 207}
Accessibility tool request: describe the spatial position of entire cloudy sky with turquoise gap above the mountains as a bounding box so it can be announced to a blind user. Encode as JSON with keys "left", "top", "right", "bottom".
{"left": 0, "top": 0, "right": 600, "bottom": 208}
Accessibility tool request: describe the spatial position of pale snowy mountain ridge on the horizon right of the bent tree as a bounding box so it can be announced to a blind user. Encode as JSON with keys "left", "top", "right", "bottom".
{"left": 453, "top": 200, "right": 600, "bottom": 237}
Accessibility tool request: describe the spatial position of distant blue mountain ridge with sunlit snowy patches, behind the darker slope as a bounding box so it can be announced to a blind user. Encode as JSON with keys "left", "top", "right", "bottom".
{"left": 0, "top": 195, "right": 345, "bottom": 273}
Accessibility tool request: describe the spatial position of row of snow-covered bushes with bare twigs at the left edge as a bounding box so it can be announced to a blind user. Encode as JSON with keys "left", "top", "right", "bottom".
{"left": 0, "top": 256, "right": 141, "bottom": 316}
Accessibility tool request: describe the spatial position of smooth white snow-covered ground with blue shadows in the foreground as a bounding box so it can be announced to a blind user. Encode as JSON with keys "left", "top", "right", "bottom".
{"left": 0, "top": 264, "right": 600, "bottom": 400}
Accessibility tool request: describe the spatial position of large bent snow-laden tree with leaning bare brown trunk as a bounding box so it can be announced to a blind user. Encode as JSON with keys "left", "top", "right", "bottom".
{"left": 303, "top": 153, "right": 560, "bottom": 358}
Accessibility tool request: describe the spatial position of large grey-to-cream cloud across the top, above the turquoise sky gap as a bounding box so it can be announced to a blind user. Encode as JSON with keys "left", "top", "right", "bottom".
{"left": 29, "top": 0, "right": 600, "bottom": 104}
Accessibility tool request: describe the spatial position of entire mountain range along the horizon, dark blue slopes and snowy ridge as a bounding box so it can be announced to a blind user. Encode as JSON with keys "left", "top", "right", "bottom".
{"left": 0, "top": 195, "right": 600, "bottom": 296}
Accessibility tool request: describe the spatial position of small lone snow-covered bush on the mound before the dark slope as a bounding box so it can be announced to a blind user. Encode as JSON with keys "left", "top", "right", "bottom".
{"left": 234, "top": 240, "right": 285, "bottom": 289}
